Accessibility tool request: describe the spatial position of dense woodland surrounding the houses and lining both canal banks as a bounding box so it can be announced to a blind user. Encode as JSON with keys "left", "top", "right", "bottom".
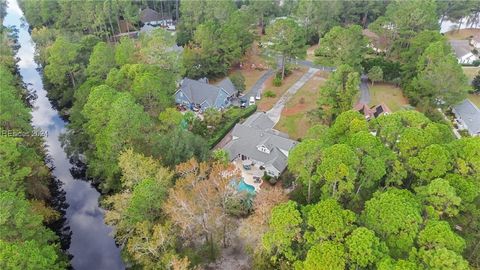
{"left": 0, "top": 0, "right": 480, "bottom": 269}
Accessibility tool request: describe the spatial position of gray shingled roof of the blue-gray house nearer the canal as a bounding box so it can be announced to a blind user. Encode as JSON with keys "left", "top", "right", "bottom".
{"left": 180, "top": 78, "right": 230, "bottom": 105}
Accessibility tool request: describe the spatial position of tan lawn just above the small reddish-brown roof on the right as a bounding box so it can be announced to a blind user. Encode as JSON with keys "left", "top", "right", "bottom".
{"left": 369, "top": 83, "right": 408, "bottom": 112}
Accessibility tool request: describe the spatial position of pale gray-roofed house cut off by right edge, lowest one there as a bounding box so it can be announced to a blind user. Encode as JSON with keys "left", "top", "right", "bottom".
{"left": 452, "top": 99, "right": 480, "bottom": 136}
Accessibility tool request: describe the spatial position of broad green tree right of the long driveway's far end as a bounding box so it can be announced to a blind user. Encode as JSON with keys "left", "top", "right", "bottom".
{"left": 315, "top": 25, "right": 367, "bottom": 70}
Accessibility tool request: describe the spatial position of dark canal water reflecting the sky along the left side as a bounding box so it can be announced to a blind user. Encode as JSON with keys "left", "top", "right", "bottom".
{"left": 4, "top": 0, "right": 125, "bottom": 270}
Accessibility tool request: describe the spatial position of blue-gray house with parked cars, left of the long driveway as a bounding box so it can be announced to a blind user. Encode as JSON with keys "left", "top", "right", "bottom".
{"left": 175, "top": 78, "right": 238, "bottom": 112}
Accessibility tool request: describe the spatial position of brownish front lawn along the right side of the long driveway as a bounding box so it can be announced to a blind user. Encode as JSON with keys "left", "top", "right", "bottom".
{"left": 275, "top": 72, "right": 325, "bottom": 139}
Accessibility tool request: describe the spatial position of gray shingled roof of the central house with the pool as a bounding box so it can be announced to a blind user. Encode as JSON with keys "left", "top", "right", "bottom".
{"left": 224, "top": 123, "right": 298, "bottom": 172}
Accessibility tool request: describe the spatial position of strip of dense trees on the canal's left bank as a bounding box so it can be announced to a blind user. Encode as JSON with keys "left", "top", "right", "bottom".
{"left": 0, "top": 6, "right": 67, "bottom": 269}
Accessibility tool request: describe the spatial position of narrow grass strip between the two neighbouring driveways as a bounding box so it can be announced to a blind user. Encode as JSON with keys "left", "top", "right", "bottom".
{"left": 257, "top": 67, "right": 308, "bottom": 112}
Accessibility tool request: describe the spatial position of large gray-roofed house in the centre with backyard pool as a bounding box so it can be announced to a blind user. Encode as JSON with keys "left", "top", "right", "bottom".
{"left": 223, "top": 112, "right": 298, "bottom": 177}
